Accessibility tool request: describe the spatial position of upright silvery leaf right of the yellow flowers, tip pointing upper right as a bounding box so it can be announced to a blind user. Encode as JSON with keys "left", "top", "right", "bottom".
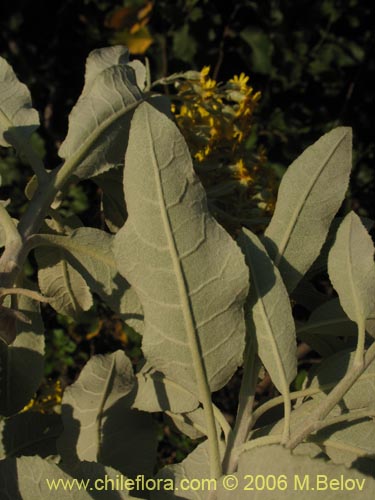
{"left": 265, "top": 127, "right": 352, "bottom": 292}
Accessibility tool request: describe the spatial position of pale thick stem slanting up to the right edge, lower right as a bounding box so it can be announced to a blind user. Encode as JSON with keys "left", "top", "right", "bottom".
{"left": 286, "top": 342, "right": 375, "bottom": 450}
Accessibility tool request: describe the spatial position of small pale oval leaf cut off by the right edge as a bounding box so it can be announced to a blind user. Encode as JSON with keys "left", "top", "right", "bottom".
{"left": 328, "top": 212, "right": 375, "bottom": 324}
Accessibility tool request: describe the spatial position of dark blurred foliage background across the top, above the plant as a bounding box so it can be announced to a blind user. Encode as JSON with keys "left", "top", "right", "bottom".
{"left": 0, "top": 0, "right": 375, "bottom": 217}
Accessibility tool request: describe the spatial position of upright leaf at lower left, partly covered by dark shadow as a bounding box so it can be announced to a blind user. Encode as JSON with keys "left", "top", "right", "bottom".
{"left": 58, "top": 351, "right": 156, "bottom": 476}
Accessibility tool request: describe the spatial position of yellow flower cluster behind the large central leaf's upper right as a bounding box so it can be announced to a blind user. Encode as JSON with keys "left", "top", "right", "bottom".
{"left": 172, "top": 66, "right": 275, "bottom": 227}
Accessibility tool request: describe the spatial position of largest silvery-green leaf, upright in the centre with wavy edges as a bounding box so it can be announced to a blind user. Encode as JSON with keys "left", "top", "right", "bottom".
{"left": 114, "top": 103, "right": 248, "bottom": 394}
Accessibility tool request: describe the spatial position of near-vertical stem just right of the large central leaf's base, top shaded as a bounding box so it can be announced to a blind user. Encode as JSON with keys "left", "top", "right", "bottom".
{"left": 223, "top": 335, "right": 260, "bottom": 474}
